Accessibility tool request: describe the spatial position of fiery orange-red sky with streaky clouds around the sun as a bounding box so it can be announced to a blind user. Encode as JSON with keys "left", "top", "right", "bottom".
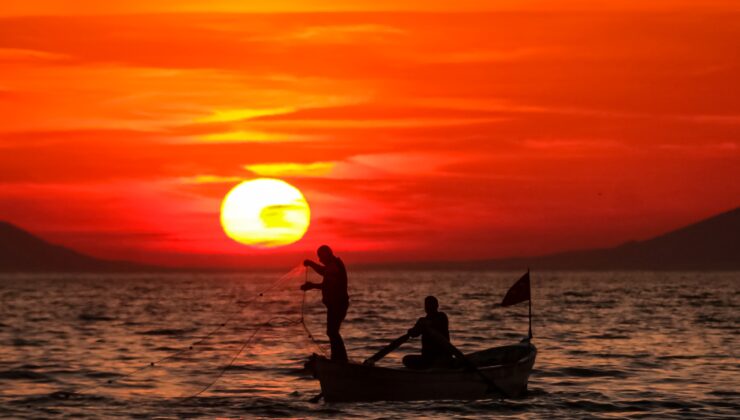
{"left": 0, "top": 0, "right": 740, "bottom": 266}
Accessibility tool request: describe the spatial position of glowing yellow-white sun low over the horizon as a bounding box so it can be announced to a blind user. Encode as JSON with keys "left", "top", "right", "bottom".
{"left": 221, "top": 178, "right": 311, "bottom": 248}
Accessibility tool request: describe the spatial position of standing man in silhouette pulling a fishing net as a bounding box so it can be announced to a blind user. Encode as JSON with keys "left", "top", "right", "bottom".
{"left": 301, "top": 245, "right": 349, "bottom": 362}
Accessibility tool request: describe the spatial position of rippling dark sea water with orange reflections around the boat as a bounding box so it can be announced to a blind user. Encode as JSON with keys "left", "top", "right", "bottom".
{"left": 0, "top": 271, "right": 740, "bottom": 419}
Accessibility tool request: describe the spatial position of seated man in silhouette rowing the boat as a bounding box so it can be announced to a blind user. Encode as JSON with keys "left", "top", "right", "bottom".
{"left": 403, "top": 296, "right": 452, "bottom": 369}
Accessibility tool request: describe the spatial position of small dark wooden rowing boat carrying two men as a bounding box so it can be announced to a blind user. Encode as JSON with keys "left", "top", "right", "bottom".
{"left": 307, "top": 339, "right": 537, "bottom": 402}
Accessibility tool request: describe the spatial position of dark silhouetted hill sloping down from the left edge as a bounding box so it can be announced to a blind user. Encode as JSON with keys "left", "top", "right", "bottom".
{"left": 0, "top": 222, "right": 156, "bottom": 272}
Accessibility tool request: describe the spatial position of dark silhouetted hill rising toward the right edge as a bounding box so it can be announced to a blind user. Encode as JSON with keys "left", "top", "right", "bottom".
{"left": 370, "top": 207, "right": 740, "bottom": 270}
